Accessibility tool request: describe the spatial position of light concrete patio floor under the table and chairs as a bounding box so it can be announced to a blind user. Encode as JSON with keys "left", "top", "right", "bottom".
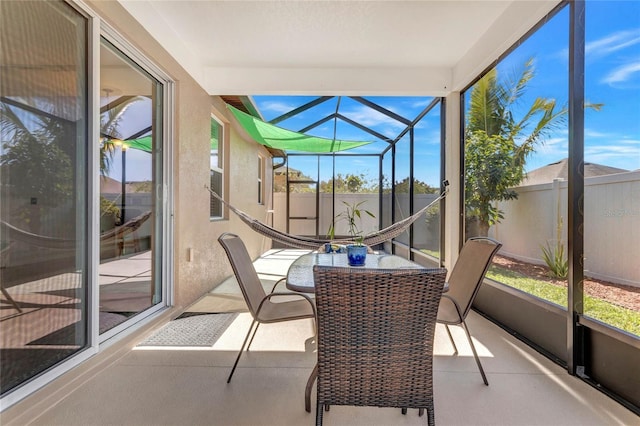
{"left": 2, "top": 250, "right": 639, "bottom": 425}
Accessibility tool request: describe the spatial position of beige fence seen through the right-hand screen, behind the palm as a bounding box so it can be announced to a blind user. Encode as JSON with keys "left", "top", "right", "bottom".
{"left": 489, "top": 171, "right": 640, "bottom": 287}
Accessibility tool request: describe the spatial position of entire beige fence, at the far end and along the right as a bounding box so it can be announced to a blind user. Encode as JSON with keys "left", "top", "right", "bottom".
{"left": 273, "top": 171, "right": 640, "bottom": 287}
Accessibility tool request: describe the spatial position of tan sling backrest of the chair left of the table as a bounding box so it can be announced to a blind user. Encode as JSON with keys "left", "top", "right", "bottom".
{"left": 218, "top": 232, "right": 266, "bottom": 318}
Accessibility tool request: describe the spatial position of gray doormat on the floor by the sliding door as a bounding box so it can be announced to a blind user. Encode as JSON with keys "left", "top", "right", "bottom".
{"left": 138, "top": 313, "right": 238, "bottom": 347}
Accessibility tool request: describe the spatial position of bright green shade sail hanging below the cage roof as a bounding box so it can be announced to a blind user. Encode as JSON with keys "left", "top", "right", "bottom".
{"left": 227, "top": 105, "right": 371, "bottom": 153}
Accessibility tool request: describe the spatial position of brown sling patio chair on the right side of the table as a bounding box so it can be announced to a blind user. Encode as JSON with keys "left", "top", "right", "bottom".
{"left": 438, "top": 237, "right": 502, "bottom": 386}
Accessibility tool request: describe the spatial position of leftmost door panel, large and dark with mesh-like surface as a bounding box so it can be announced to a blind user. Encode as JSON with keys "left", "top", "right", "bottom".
{"left": 0, "top": 1, "right": 88, "bottom": 395}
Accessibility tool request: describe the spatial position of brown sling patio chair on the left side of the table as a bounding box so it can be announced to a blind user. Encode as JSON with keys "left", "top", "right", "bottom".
{"left": 218, "top": 232, "right": 316, "bottom": 383}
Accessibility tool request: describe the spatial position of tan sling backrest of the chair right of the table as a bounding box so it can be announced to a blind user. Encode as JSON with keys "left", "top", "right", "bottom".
{"left": 446, "top": 237, "right": 502, "bottom": 320}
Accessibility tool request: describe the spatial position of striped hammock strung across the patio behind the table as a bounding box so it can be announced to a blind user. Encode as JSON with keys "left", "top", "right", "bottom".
{"left": 205, "top": 184, "right": 448, "bottom": 250}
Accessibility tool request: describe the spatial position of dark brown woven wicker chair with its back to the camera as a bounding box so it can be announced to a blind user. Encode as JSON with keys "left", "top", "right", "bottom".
{"left": 314, "top": 265, "right": 446, "bottom": 425}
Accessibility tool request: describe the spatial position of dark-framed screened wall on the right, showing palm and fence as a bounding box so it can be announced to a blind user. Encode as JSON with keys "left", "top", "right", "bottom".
{"left": 462, "top": 1, "right": 640, "bottom": 412}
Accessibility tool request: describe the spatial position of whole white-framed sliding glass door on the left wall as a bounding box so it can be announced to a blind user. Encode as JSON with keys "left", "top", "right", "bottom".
{"left": 0, "top": 1, "right": 171, "bottom": 406}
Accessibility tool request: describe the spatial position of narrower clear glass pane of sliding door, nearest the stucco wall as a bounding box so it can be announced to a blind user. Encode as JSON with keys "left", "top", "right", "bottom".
{"left": 99, "top": 39, "right": 162, "bottom": 333}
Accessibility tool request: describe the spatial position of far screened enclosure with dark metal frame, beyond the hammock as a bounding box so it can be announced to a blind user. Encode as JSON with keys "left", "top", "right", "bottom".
{"left": 245, "top": 96, "right": 444, "bottom": 258}
